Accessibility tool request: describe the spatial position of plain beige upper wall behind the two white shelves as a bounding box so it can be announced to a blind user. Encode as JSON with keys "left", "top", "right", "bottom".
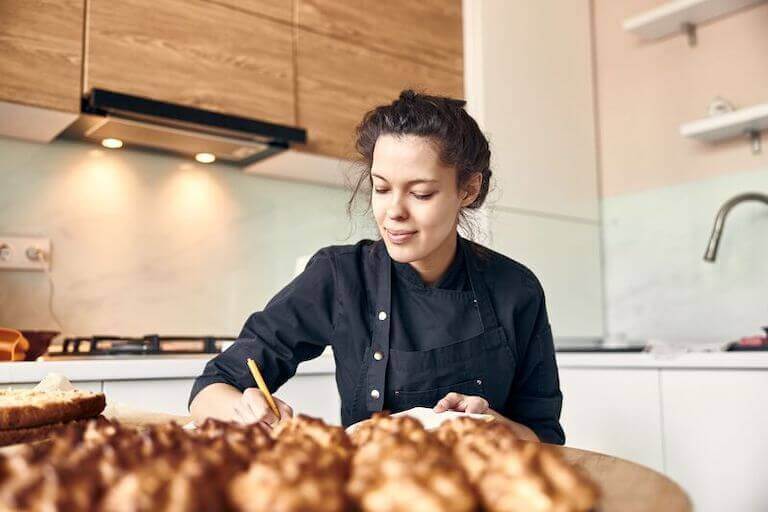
{"left": 594, "top": 0, "right": 768, "bottom": 197}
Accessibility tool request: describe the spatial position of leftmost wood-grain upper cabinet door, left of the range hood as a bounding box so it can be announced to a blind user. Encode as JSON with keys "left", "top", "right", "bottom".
{"left": 0, "top": 0, "right": 84, "bottom": 112}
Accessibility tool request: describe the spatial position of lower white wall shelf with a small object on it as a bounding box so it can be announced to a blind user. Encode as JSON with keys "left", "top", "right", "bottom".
{"left": 680, "top": 103, "right": 768, "bottom": 142}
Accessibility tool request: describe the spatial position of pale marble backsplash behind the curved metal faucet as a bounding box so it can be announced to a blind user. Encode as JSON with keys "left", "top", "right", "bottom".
{"left": 603, "top": 169, "right": 768, "bottom": 342}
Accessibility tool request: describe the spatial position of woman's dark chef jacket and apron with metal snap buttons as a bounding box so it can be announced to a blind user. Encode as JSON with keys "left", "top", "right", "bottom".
{"left": 190, "top": 236, "right": 565, "bottom": 444}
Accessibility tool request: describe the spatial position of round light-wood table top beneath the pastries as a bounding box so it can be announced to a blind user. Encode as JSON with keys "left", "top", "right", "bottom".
{"left": 109, "top": 414, "right": 693, "bottom": 512}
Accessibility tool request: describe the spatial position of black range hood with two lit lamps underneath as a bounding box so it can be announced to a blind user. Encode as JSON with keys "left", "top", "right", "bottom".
{"left": 61, "top": 89, "right": 307, "bottom": 167}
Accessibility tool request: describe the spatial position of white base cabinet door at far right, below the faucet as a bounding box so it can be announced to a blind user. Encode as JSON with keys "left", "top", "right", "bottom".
{"left": 661, "top": 370, "right": 768, "bottom": 512}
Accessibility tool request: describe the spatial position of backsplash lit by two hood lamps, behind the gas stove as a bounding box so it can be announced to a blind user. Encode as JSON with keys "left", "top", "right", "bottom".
{"left": 0, "top": 137, "right": 371, "bottom": 335}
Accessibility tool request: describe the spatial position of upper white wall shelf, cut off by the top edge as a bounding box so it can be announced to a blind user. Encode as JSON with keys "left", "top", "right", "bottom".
{"left": 623, "top": 0, "right": 766, "bottom": 40}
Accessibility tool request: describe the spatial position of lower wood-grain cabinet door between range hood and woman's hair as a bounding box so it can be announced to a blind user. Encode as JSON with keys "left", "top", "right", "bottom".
{"left": 297, "top": 29, "right": 463, "bottom": 158}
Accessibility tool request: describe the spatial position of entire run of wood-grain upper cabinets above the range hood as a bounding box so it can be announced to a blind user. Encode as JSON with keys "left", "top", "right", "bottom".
{"left": 0, "top": 0, "right": 464, "bottom": 158}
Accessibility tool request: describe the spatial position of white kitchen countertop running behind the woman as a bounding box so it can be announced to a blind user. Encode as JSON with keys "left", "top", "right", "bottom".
{"left": 0, "top": 351, "right": 768, "bottom": 384}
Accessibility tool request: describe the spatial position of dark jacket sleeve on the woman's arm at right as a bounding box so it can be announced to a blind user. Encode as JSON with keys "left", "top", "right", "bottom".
{"left": 505, "top": 283, "right": 565, "bottom": 445}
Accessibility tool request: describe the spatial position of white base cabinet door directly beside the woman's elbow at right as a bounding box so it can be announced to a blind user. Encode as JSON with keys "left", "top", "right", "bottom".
{"left": 560, "top": 368, "right": 664, "bottom": 471}
